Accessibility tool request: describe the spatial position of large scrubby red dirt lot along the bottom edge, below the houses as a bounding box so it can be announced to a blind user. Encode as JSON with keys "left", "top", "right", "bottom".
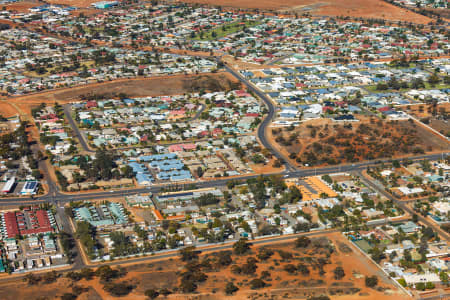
{"left": 0, "top": 233, "right": 408, "bottom": 300}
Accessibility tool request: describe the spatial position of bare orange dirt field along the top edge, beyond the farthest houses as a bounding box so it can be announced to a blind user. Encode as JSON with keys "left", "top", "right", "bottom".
{"left": 178, "top": 0, "right": 431, "bottom": 24}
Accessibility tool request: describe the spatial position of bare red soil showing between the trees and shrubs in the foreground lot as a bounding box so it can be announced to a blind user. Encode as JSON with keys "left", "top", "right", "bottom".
{"left": 0, "top": 233, "right": 410, "bottom": 300}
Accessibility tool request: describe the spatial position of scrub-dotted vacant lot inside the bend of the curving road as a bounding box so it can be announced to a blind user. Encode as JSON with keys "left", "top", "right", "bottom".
{"left": 268, "top": 116, "right": 449, "bottom": 166}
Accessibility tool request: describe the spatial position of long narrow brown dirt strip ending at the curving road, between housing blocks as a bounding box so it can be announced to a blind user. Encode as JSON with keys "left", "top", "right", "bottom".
{"left": 3, "top": 73, "right": 241, "bottom": 114}
